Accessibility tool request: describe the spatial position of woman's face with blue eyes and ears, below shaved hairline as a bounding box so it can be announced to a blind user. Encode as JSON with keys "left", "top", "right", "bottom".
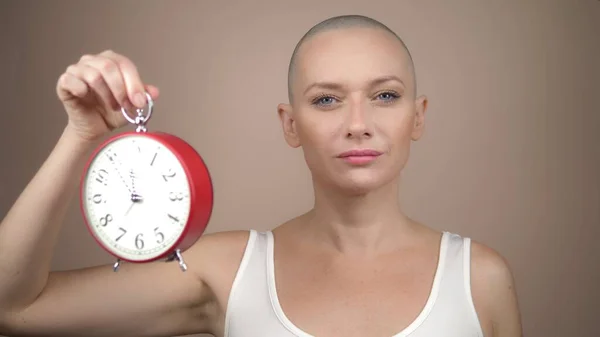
{"left": 279, "top": 28, "right": 426, "bottom": 193}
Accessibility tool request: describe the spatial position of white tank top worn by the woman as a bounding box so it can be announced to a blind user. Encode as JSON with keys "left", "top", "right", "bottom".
{"left": 224, "top": 230, "right": 483, "bottom": 337}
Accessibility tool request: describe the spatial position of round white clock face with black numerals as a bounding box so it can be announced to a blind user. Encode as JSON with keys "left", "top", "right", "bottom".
{"left": 82, "top": 134, "right": 190, "bottom": 261}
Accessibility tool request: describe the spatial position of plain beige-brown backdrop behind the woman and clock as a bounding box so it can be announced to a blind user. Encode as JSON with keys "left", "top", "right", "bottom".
{"left": 0, "top": 0, "right": 600, "bottom": 337}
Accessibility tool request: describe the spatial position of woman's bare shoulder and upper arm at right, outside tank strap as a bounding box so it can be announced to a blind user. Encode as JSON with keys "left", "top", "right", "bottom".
{"left": 471, "top": 240, "right": 522, "bottom": 337}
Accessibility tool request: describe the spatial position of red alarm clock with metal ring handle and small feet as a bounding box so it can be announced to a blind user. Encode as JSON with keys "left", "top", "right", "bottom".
{"left": 80, "top": 93, "right": 213, "bottom": 271}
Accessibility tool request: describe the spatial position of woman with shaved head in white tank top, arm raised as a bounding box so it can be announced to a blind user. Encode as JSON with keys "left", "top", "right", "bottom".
{"left": 0, "top": 16, "right": 521, "bottom": 337}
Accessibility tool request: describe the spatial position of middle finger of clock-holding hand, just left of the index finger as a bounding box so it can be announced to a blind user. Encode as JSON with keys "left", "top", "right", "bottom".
{"left": 79, "top": 55, "right": 129, "bottom": 107}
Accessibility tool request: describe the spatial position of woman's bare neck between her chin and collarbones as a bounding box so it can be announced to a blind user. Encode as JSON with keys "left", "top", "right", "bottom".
{"left": 307, "top": 181, "right": 411, "bottom": 256}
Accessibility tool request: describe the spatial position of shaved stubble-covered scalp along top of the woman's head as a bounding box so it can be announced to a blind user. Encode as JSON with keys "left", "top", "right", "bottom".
{"left": 288, "top": 15, "right": 416, "bottom": 103}
